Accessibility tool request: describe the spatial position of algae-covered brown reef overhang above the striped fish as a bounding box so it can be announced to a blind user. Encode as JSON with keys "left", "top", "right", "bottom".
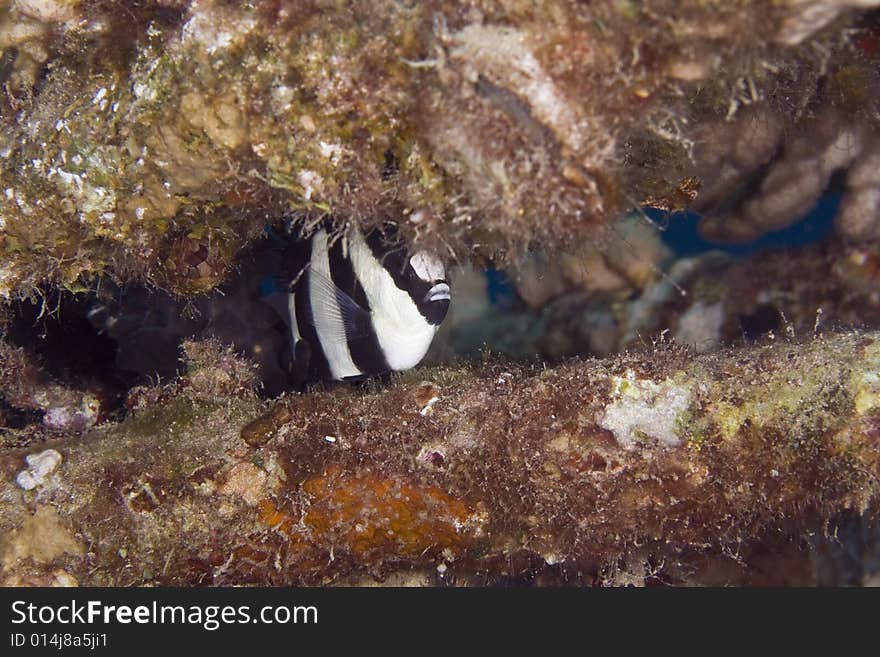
{"left": 0, "top": 0, "right": 877, "bottom": 299}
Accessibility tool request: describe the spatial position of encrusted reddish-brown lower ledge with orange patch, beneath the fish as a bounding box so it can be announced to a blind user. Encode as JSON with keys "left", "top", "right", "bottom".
{"left": 0, "top": 332, "right": 880, "bottom": 585}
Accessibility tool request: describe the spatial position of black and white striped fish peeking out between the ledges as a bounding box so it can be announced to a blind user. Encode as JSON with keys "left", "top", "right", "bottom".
{"left": 284, "top": 226, "right": 451, "bottom": 385}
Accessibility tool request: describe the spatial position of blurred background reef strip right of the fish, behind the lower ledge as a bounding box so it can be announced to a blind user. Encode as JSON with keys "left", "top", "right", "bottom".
{"left": 435, "top": 234, "right": 880, "bottom": 363}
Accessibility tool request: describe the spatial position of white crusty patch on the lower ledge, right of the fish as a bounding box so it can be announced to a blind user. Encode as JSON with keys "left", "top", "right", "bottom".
{"left": 596, "top": 371, "right": 691, "bottom": 449}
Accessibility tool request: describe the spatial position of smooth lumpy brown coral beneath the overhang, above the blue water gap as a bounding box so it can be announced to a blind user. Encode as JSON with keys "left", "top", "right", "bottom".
{"left": 693, "top": 107, "right": 877, "bottom": 242}
